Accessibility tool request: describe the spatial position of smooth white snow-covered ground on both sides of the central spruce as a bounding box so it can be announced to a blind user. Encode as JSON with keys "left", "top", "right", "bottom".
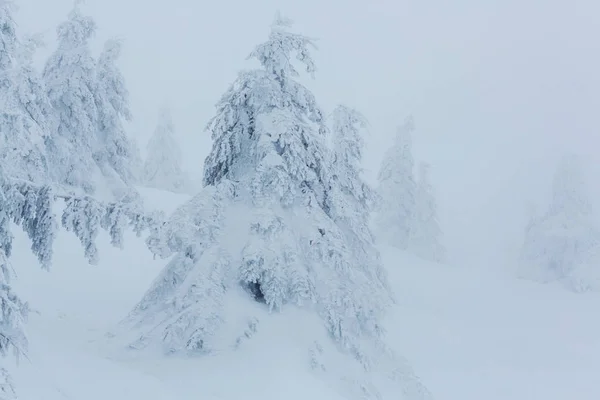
{"left": 5, "top": 189, "right": 600, "bottom": 400}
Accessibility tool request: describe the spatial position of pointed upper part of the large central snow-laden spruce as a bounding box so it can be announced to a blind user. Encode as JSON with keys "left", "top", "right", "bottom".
{"left": 203, "top": 14, "right": 326, "bottom": 186}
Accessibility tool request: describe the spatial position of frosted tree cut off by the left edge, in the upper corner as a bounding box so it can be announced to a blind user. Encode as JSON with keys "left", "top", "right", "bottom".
{"left": 0, "top": 0, "right": 52, "bottom": 181}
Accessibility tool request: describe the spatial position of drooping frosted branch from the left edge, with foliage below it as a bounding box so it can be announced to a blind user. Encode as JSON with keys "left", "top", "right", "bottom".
{"left": 0, "top": 166, "right": 162, "bottom": 399}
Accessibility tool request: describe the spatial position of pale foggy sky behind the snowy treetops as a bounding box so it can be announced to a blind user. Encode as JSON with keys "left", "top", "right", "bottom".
{"left": 17, "top": 0, "right": 600, "bottom": 265}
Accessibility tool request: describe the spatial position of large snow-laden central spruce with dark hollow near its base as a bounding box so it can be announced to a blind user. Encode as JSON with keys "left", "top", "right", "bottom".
{"left": 124, "top": 16, "right": 428, "bottom": 398}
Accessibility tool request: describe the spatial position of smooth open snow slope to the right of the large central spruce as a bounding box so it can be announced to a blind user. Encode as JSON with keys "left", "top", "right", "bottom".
{"left": 383, "top": 249, "right": 600, "bottom": 400}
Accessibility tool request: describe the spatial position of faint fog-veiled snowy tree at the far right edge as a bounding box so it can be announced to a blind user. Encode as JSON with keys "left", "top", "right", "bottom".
{"left": 519, "top": 156, "right": 600, "bottom": 290}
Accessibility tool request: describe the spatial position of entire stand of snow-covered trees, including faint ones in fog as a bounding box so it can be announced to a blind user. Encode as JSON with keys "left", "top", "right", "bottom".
{"left": 0, "top": 0, "right": 599, "bottom": 399}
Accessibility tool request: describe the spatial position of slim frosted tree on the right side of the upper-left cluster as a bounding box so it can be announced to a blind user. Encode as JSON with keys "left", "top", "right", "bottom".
{"left": 94, "top": 40, "right": 137, "bottom": 185}
